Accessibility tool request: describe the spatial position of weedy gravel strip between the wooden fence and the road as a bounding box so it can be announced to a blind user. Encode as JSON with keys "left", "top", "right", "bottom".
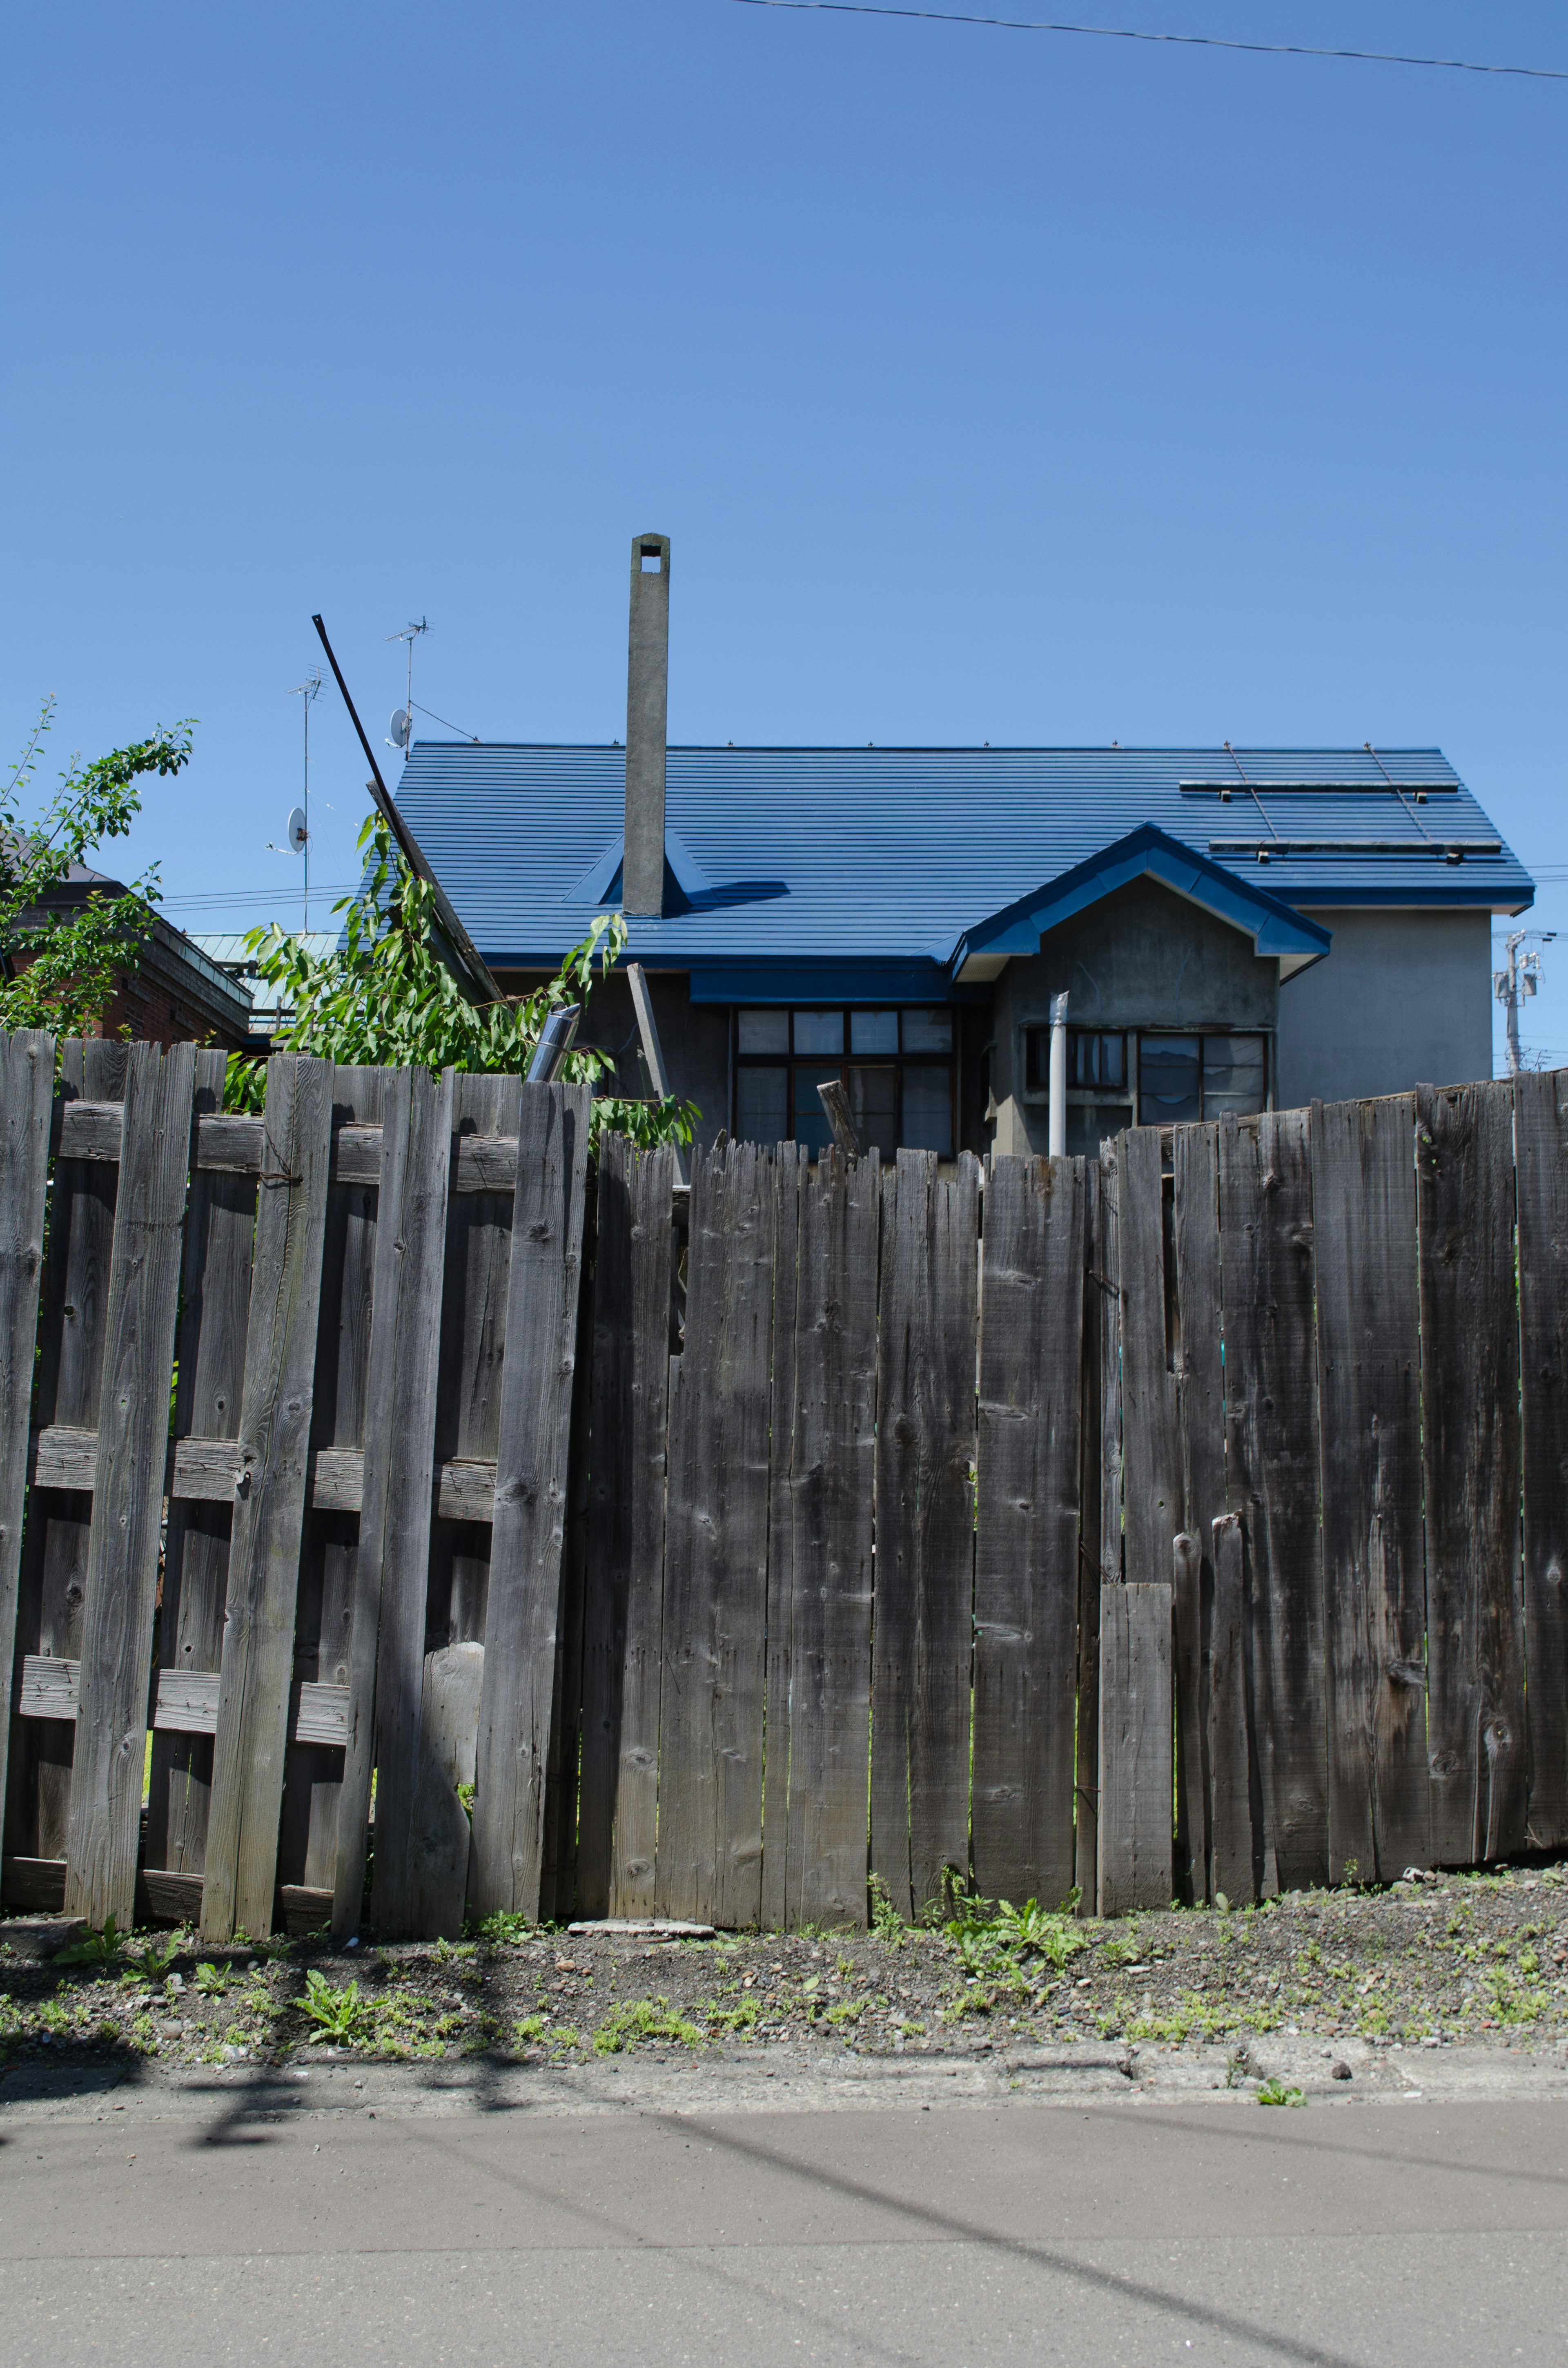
{"left": 0, "top": 1866, "right": 1568, "bottom": 2100}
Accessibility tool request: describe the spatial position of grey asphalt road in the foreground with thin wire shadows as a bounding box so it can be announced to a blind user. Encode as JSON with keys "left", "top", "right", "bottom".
{"left": 0, "top": 2098, "right": 1568, "bottom": 2368}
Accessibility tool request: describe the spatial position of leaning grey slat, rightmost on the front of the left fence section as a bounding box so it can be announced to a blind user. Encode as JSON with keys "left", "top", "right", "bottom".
{"left": 469, "top": 1084, "right": 590, "bottom": 1916}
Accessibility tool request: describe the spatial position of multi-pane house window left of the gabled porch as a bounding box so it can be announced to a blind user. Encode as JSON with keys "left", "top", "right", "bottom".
{"left": 734, "top": 1009, "right": 955, "bottom": 1158}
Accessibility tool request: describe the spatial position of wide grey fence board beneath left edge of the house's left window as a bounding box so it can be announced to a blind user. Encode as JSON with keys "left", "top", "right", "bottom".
{"left": 654, "top": 1144, "right": 772, "bottom": 1925}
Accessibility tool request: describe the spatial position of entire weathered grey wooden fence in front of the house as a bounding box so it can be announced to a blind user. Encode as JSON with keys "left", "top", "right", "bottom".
{"left": 0, "top": 1035, "right": 1568, "bottom": 1940}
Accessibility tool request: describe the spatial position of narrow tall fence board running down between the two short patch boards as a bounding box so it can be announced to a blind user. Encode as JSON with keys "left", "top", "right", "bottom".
{"left": 1172, "top": 1125, "right": 1225, "bottom": 1899}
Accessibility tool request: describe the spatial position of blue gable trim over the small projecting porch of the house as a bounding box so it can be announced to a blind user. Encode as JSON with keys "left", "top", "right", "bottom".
{"left": 950, "top": 822, "right": 1334, "bottom": 985}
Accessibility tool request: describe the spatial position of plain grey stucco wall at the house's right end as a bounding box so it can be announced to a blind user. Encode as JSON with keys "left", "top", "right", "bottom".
{"left": 1277, "top": 909, "right": 1492, "bottom": 1108}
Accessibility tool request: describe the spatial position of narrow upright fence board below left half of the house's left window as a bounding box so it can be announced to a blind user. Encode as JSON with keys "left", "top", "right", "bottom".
{"left": 763, "top": 1144, "right": 810, "bottom": 1932}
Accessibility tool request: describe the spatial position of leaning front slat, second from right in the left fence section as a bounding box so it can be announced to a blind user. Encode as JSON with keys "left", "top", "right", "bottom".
{"left": 367, "top": 1068, "right": 464, "bottom": 1935}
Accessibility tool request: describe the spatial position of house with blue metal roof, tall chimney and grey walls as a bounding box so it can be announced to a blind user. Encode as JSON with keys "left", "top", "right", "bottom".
{"left": 396, "top": 535, "right": 1535, "bottom": 1155}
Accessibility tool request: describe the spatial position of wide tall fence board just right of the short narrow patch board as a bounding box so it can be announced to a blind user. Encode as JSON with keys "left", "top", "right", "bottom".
{"left": 1220, "top": 1110, "right": 1329, "bottom": 1892}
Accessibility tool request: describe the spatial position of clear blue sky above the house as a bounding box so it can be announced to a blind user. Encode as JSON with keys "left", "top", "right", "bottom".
{"left": 0, "top": 0, "right": 1568, "bottom": 1061}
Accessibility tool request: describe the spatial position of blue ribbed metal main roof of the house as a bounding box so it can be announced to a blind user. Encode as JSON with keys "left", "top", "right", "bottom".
{"left": 396, "top": 741, "right": 1535, "bottom": 999}
